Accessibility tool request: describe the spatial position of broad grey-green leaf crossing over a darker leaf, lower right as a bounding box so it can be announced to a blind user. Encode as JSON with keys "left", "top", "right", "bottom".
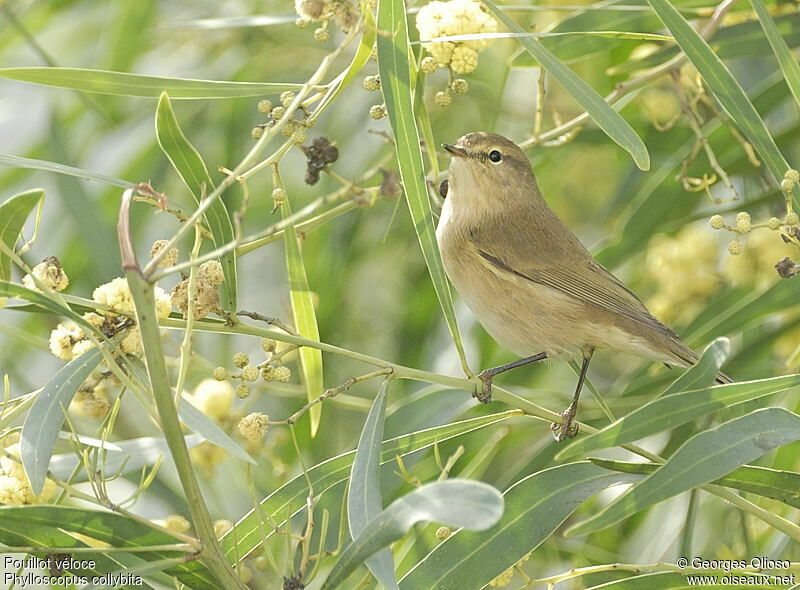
{"left": 567, "top": 408, "right": 800, "bottom": 536}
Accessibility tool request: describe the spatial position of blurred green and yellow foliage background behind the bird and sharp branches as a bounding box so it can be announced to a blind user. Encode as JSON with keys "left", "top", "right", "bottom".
{"left": 0, "top": 0, "right": 800, "bottom": 588}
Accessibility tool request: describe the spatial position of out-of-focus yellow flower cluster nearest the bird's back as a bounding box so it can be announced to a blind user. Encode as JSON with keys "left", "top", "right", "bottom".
{"left": 646, "top": 225, "right": 721, "bottom": 323}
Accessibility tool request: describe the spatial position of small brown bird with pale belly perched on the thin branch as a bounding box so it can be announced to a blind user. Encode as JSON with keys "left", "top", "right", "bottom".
{"left": 436, "top": 132, "right": 730, "bottom": 441}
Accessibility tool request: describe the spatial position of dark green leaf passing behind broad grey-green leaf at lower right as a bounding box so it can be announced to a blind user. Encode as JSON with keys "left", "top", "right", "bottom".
{"left": 589, "top": 457, "right": 800, "bottom": 508}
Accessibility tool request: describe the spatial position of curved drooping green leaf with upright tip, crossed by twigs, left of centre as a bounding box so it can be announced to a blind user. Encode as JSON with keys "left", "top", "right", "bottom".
{"left": 156, "top": 93, "right": 236, "bottom": 313}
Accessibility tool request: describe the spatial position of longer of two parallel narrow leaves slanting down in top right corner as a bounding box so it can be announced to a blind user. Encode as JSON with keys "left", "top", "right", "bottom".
{"left": 647, "top": 0, "right": 800, "bottom": 199}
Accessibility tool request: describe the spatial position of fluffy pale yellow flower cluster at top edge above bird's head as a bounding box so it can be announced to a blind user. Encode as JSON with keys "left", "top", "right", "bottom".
{"left": 417, "top": 0, "right": 497, "bottom": 74}
